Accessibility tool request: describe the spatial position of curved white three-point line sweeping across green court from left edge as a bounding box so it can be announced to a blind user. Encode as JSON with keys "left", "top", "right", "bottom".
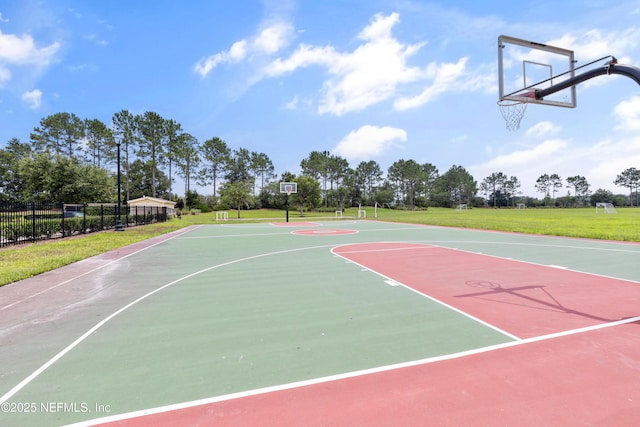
{"left": 0, "top": 240, "right": 340, "bottom": 404}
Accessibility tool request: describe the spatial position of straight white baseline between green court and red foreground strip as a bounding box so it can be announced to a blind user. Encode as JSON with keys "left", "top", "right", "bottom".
{"left": 63, "top": 316, "right": 640, "bottom": 427}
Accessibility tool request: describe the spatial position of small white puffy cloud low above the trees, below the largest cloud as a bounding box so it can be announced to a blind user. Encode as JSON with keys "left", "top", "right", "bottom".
{"left": 332, "top": 125, "right": 407, "bottom": 162}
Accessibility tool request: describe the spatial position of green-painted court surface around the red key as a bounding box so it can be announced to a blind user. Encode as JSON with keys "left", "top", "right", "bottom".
{"left": 0, "top": 221, "right": 640, "bottom": 426}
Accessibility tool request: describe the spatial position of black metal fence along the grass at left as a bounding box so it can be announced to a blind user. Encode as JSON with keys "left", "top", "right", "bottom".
{"left": 0, "top": 202, "right": 168, "bottom": 247}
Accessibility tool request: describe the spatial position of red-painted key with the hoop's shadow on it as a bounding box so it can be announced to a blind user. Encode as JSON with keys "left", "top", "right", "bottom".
{"left": 334, "top": 243, "right": 640, "bottom": 338}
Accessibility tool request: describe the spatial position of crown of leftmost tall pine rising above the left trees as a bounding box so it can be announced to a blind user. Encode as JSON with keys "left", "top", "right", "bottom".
{"left": 31, "top": 113, "right": 84, "bottom": 158}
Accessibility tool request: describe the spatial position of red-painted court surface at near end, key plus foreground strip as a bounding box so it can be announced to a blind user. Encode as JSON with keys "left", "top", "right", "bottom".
{"left": 89, "top": 243, "right": 640, "bottom": 426}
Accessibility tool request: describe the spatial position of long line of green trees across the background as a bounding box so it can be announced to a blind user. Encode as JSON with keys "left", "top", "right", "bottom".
{"left": 0, "top": 110, "right": 640, "bottom": 209}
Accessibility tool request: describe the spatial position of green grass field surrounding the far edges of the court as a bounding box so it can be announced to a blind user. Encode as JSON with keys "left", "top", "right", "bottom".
{"left": 0, "top": 207, "right": 640, "bottom": 286}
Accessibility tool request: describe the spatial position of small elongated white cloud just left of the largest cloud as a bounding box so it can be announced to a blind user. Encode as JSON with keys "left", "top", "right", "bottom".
{"left": 194, "top": 22, "right": 293, "bottom": 77}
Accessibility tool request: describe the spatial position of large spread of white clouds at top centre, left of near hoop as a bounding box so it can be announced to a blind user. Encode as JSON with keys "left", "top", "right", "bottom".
{"left": 205, "top": 13, "right": 480, "bottom": 116}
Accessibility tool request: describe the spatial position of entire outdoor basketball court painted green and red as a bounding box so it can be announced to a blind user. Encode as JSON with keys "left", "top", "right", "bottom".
{"left": 0, "top": 220, "right": 640, "bottom": 426}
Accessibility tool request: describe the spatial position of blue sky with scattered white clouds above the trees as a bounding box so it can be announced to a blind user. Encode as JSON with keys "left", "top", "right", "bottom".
{"left": 0, "top": 0, "right": 640, "bottom": 198}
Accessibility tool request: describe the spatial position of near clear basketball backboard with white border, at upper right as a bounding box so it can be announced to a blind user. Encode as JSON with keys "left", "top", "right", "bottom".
{"left": 498, "top": 35, "right": 576, "bottom": 108}
